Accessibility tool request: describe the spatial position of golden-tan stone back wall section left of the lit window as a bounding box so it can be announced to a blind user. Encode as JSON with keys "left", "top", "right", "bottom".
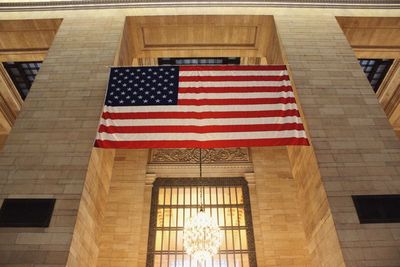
{"left": 94, "top": 149, "right": 151, "bottom": 267}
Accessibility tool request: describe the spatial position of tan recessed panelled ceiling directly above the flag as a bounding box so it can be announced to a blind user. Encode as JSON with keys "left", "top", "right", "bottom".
{"left": 124, "top": 15, "right": 275, "bottom": 61}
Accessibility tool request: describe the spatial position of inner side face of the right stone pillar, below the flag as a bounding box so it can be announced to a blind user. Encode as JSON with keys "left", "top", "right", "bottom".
{"left": 288, "top": 147, "right": 345, "bottom": 266}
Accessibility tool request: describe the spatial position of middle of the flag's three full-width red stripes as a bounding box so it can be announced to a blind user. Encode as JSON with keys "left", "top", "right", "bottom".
{"left": 99, "top": 123, "right": 304, "bottom": 134}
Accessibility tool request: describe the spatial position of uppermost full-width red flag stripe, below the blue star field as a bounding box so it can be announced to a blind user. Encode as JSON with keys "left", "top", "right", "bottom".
{"left": 102, "top": 109, "right": 300, "bottom": 120}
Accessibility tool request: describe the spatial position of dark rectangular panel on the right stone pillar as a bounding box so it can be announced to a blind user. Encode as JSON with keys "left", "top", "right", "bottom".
{"left": 352, "top": 195, "right": 400, "bottom": 223}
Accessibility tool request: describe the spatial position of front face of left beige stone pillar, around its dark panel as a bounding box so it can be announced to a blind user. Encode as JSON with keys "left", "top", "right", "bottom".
{"left": 0, "top": 17, "right": 124, "bottom": 266}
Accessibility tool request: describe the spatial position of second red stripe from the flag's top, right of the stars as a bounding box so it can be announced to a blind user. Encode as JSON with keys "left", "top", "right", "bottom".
{"left": 179, "top": 75, "right": 289, "bottom": 82}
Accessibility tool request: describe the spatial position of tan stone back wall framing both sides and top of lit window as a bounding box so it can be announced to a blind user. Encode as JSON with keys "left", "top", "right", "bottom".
{"left": 97, "top": 148, "right": 310, "bottom": 267}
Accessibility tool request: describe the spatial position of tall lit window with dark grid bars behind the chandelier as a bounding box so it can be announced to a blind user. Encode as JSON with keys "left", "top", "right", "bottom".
{"left": 146, "top": 178, "right": 256, "bottom": 267}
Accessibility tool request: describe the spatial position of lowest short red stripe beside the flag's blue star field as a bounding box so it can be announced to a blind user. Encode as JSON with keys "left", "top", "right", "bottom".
{"left": 178, "top": 97, "right": 296, "bottom": 106}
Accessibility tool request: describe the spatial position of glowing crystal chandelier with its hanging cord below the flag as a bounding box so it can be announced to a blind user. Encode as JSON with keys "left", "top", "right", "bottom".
{"left": 183, "top": 149, "right": 222, "bottom": 265}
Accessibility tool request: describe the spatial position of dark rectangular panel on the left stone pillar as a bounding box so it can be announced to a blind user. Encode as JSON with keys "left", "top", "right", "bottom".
{"left": 0, "top": 198, "right": 56, "bottom": 227}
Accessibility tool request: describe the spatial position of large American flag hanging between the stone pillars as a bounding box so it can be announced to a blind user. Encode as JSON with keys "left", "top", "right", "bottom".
{"left": 95, "top": 65, "right": 308, "bottom": 148}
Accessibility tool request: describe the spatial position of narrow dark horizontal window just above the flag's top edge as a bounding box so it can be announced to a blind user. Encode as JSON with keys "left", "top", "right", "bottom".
{"left": 158, "top": 57, "right": 240, "bottom": 66}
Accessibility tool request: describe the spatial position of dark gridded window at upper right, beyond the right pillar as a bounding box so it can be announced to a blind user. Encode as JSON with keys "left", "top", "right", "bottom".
{"left": 359, "top": 59, "right": 393, "bottom": 93}
